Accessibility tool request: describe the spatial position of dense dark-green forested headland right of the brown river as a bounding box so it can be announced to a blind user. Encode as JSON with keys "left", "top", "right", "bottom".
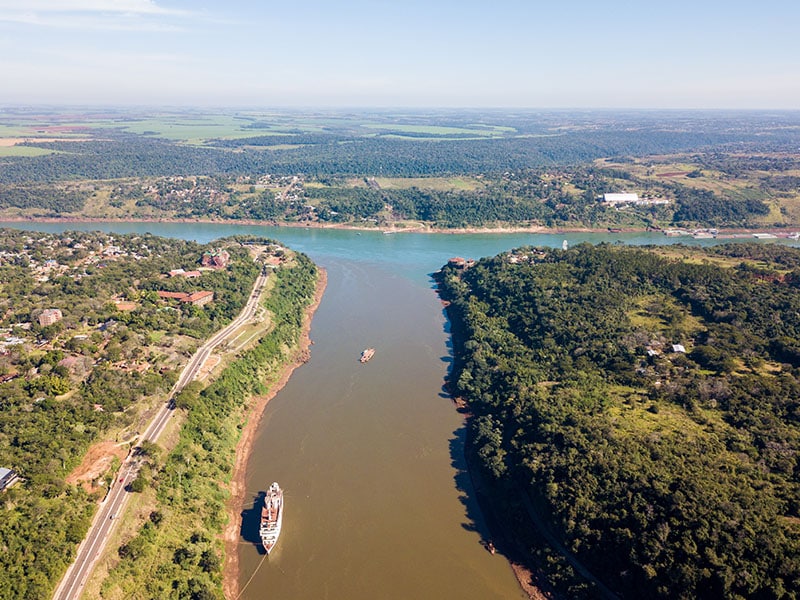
{"left": 438, "top": 244, "right": 800, "bottom": 598}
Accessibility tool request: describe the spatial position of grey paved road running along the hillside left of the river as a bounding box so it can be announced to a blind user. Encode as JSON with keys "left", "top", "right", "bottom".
{"left": 53, "top": 272, "right": 267, "bottom": 600}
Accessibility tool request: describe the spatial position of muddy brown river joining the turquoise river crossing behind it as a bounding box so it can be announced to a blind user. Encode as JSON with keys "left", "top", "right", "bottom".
{"left": 0, "top": 223, "right": 788, "bottom": 600}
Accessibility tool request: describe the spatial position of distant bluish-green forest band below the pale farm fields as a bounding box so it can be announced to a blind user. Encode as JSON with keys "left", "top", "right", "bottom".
{"left": 0, "top": 125, "right": 787, "bottom": 184}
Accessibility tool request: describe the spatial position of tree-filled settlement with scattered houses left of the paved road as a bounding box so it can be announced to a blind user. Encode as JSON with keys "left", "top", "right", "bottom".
{"left": 0, "top": 230, "right": 268, "bottom": 598}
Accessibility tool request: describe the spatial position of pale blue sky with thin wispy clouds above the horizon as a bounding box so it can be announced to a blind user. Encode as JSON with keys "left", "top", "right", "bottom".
{"left": 0, "top": 0, "right": 800, "bottom": 109}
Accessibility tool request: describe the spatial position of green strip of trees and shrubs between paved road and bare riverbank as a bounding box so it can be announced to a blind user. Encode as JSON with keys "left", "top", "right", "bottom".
{"left": 101, "top": 254, "right": 318, "bottom": 600}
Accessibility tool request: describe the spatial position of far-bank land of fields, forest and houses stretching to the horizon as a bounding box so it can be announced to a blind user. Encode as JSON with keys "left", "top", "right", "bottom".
{"left": 0, "top": 109, "right": 800, "bottom": 234}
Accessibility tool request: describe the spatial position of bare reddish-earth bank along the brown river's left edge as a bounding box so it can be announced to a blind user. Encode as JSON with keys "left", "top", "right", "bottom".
{"left": 222, "top": 267, "right": 328, "bottom": 598}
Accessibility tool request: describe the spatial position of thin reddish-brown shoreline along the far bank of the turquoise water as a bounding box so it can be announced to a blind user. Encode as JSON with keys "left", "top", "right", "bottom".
{"left": 0, "top": 216, "right": 800, "bottom": 239}
